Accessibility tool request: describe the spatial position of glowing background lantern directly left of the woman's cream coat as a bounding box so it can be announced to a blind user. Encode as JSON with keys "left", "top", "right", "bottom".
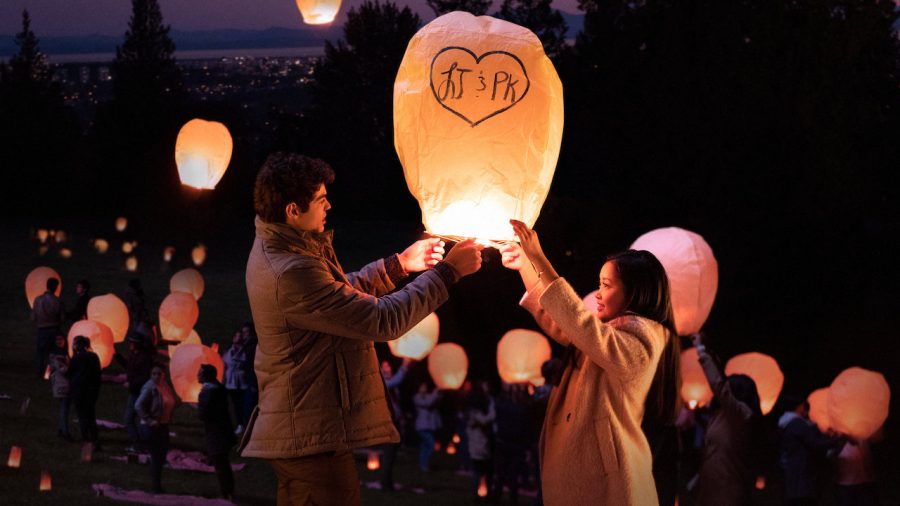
{"left": 497, "top": 329, "right": 551, "bottom": 386}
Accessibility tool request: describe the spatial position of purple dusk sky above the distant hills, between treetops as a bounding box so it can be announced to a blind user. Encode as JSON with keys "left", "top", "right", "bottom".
{"left": 0, "top": 0, "right": 578, "bottom": 36}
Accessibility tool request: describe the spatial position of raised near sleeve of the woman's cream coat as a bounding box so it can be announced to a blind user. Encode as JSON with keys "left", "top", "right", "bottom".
{"left": 540, "top": 278, "right": 665, "bottom": 379}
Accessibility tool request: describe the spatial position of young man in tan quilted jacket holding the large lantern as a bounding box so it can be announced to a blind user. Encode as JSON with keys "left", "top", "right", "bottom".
{"left": 242, "top": 153, "right": 481, "bottom": 506}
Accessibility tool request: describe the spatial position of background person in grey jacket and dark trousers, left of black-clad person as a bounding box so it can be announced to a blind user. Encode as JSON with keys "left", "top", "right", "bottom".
{"left": 135, "top": 365, "right": 175, "bottom": 494}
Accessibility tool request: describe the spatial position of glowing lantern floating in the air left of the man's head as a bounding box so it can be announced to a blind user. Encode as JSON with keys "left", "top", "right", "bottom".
{"left": 175, "top": 118, "right": 232, "bottom": 190}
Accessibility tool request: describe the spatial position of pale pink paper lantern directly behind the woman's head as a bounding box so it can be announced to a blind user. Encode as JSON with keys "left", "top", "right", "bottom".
{"left": 631, "top": 227, "right": 719, "bottom": 336}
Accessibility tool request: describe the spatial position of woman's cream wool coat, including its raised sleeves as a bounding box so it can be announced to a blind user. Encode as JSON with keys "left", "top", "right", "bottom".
{"left": 521, "top": 278, "right": 668, "bottom": 506}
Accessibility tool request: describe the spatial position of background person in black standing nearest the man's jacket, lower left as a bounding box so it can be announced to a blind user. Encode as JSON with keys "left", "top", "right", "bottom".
{"left": 197, "top": 364, "right": 236, "bottom": 500}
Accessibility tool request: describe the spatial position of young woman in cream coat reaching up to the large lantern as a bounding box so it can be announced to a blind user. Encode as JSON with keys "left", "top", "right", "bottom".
{"left": 502, "top": 220, "right": 679, "bottom": 506}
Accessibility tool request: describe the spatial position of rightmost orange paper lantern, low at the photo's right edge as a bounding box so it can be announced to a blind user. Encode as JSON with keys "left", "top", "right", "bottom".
{"left": 828, "top": 367, "right": 891, "bottom": 440}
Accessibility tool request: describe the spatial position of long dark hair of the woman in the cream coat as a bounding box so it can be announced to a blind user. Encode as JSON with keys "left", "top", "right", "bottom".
{"left": 606, "top": 250, "right": 681, "bottom": 425}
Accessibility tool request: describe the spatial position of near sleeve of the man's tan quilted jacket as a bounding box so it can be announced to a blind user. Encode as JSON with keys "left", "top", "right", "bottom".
{"left": 276, "top": 262, "right": 448, "bottom": 341}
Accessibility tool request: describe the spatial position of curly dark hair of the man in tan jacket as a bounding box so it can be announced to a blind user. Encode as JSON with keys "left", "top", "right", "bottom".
{"left": 253, "top": 152, "right": 334, "bottom": 223}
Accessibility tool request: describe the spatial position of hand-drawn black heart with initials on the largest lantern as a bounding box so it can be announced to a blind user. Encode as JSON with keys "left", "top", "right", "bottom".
{"left": 430, "top": 46, "right": 531, "bottom": 127}
